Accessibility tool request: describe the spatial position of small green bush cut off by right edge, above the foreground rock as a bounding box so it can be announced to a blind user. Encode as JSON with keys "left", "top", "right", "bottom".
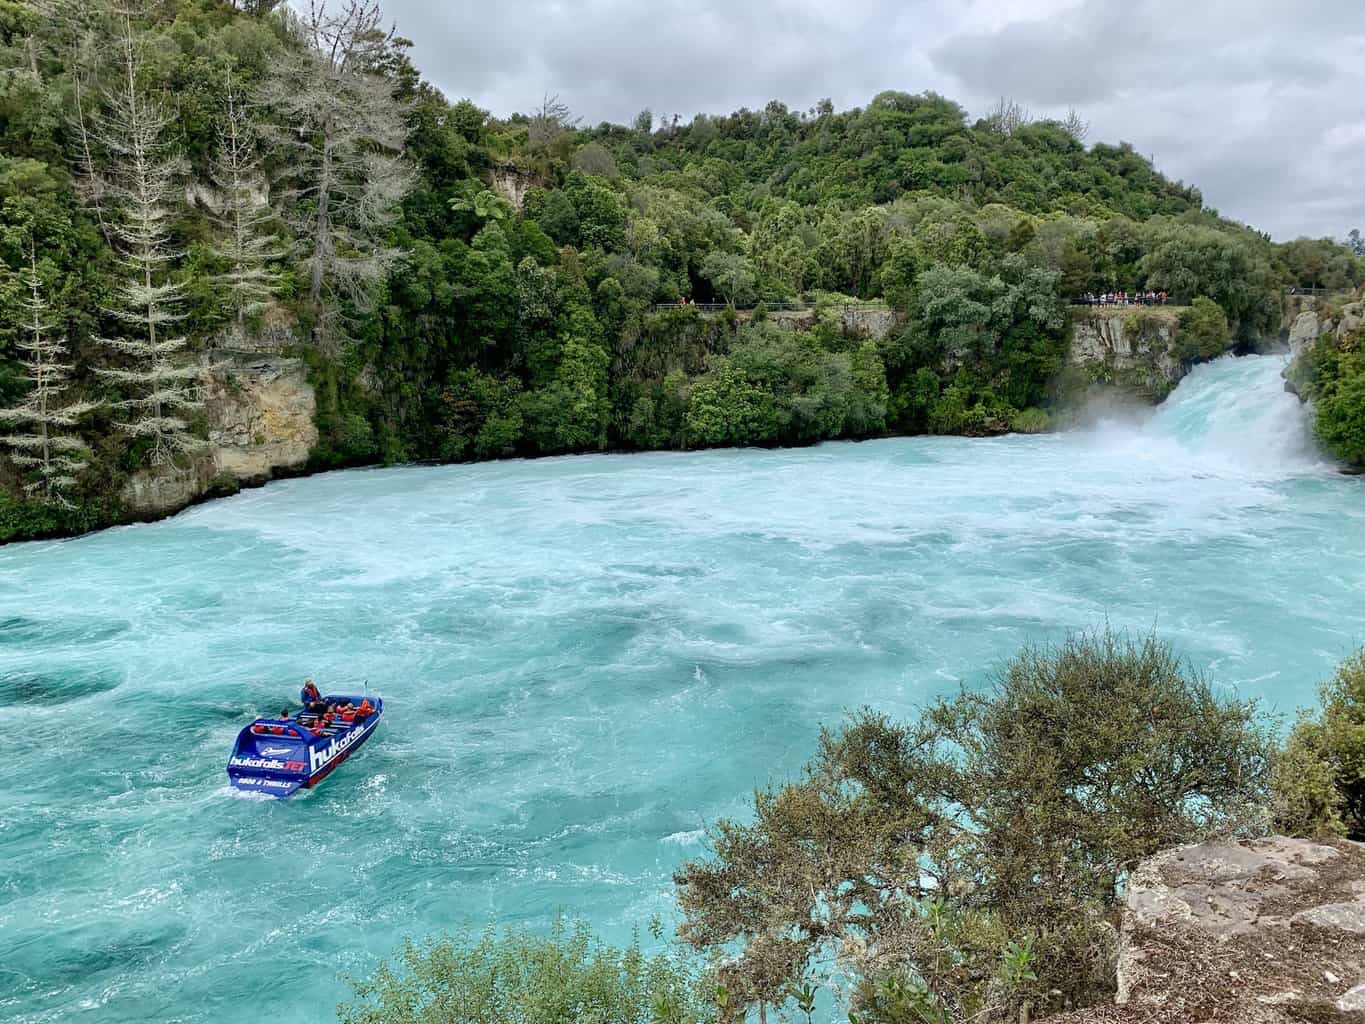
{"left": 1272, "top": 651, "right": 1365, "bottom": 840}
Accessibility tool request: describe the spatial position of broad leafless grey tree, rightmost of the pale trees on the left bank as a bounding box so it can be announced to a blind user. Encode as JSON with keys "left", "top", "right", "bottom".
{"left": 262, "top": 0, "right": 414, "bottom": 350}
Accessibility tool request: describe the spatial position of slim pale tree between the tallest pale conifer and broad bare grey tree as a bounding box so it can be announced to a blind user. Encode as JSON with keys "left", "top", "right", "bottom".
{"left": 212, "top": 76, "right": 285, "bottom": 340}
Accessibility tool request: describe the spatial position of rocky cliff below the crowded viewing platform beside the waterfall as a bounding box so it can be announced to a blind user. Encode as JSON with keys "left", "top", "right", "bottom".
{"left": 1067, "top": 309, "right": 1186, "bottom": 401}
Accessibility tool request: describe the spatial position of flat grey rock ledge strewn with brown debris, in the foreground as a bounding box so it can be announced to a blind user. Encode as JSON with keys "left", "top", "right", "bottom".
{"left": 1057, "top": 837, "right": 1365, "bottom": 1024}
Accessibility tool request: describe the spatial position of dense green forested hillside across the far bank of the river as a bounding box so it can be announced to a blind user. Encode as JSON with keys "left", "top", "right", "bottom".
{"left": 0, "top": 0, "right": 1365, "bottom": 539}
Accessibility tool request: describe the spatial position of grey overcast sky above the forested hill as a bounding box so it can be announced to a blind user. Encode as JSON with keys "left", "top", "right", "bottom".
{"left": 384, "top": 0, "right": 1365, "bottom": 239}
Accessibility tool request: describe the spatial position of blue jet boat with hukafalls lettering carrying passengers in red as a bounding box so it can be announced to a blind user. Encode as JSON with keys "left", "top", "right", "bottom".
{"left": 228, "top": 694, "right": 384, "bottom": 797}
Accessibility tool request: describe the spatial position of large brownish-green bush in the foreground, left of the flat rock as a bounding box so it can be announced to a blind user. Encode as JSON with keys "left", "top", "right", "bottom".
{"left": 677, "top": 632, "right": 1272, "bottom": 1023}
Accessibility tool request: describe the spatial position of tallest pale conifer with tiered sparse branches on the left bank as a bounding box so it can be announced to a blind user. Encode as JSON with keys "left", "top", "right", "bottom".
{"left": 98, "top": 16, "right": 205, "bottom": 466}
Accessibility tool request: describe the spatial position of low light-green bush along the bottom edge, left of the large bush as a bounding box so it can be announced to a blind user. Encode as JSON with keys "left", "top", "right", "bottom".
{"left": 340, "top": 924, "right": 715, "bottom": 1024}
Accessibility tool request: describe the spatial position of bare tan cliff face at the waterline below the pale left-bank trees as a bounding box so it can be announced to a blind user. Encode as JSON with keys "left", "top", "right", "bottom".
{"left": 120, "top": 352, "right": 318, "bottom": 516}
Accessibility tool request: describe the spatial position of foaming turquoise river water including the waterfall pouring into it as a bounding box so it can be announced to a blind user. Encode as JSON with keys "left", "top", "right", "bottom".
{"left": 0, "top": 356, "right": 1365, "bottom": 1024}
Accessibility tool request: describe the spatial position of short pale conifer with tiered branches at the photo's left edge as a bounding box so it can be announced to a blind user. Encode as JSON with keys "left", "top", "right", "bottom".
{"left": 0, "top": 250, "right": 96, "bottom": 507}
